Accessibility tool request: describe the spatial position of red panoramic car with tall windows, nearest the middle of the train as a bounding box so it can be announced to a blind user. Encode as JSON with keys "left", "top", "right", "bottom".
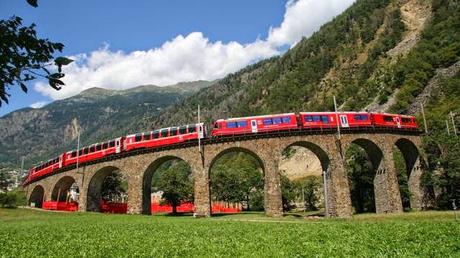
{"left": 124, "top": 123, "right": 206, "bottom": 151}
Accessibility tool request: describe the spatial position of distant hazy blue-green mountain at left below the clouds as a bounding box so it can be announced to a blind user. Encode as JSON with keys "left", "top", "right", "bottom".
{"left": 0, "top": 81, "right": 212, "bottom": 167}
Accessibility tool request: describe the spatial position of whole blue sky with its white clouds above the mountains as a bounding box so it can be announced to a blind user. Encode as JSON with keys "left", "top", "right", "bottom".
{"left": 0, "top": 0, "right": 353, "bottom": 116}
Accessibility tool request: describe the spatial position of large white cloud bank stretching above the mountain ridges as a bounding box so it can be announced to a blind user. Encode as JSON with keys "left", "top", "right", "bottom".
{"left": 34, "top": 0, "right": 354, "bottom": 99}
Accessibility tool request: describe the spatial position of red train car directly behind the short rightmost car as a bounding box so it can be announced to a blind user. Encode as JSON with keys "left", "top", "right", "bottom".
{"left": 300, "top": 112, "right": 372, "bottom": 129}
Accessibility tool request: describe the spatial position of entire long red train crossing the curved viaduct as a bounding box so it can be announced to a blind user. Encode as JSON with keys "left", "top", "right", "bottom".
{"left": 24, "top": 112, "right": 418, "bottom": 184}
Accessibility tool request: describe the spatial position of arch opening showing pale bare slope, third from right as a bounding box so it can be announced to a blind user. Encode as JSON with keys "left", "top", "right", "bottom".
{"left": 279, "top": 142, "right": 330, "bottom": 214}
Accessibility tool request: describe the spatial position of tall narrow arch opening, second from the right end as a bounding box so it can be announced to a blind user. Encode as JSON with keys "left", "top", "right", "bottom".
{"left": 345, "top": 139, "right": 386, "bottom": 213}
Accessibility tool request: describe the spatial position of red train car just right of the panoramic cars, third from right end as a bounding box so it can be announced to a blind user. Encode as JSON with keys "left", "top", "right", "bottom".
{"left": 211, "top": 113, "right": 298, "bottom": 136}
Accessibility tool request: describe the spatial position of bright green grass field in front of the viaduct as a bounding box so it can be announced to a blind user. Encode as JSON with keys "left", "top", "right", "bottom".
{"left": 0, "top": 209, "right": 460, "bottom": 257}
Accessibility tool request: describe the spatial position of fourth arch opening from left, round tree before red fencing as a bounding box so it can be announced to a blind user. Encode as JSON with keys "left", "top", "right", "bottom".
{"left": 142, "top": 156, "right": 194, "bottom": 215}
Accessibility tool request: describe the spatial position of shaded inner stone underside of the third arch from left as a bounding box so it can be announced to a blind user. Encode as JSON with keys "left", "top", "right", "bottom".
{"left": 86, "top": 166, "right": 125, "bottom": 212}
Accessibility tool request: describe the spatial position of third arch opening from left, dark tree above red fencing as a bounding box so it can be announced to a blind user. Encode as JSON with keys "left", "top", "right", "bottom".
{"left": 86, "top": 166, "right": 129, "bottom": 213}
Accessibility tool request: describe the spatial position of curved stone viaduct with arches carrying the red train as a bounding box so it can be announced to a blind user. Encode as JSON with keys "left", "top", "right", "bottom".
{"left": 26, "top": 132, "right": 424, "bottom": 217}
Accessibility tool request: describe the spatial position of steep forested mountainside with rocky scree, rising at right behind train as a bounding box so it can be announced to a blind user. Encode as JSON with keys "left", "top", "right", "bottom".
{"left": 147, "top": 0, "right": 460, "bottom": 129}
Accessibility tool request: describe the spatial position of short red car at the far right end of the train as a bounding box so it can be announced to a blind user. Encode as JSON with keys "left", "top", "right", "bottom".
{"left": 371, "top": 113, "right": 418, "bottom": 130}
